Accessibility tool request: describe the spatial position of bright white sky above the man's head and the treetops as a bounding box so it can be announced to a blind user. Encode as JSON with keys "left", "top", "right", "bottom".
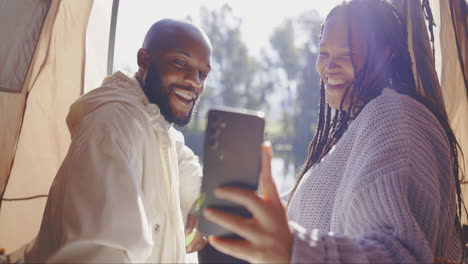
{"left": 114, "top": 0, "right": 341, "bottom": 71}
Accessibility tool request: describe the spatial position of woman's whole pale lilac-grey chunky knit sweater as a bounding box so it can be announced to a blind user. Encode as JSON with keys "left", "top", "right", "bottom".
{"left": 288, "top": 88, "right": 461, "bottom": 263}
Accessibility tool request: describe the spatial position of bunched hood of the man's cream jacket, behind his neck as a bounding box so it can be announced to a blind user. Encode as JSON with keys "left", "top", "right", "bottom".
{"left": 67, "top": 71, "right": 153, "bottom": 133}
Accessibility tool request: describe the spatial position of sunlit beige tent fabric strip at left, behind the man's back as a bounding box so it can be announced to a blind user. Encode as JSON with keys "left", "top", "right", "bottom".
{"left": 0, "top": 0, "right": 93, "bottom": 252}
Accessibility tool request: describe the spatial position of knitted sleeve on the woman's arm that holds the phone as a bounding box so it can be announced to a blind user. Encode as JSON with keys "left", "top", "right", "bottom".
{"left": 290, "top": 92, "right": 456, "bottom": 263}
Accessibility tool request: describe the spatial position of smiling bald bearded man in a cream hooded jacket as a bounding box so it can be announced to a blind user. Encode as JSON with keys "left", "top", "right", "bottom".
{"left": 25, "top": 19, "right": 211, "bottom": 263}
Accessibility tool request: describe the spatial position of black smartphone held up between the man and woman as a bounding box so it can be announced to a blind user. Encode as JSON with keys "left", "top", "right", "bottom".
{"left": 199, "top": 108, "right": 265, "bottom": 237}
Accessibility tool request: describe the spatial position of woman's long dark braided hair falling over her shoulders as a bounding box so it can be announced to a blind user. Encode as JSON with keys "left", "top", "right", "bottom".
{"left": 289, "top": 0, "right": 466, "bottom": 255}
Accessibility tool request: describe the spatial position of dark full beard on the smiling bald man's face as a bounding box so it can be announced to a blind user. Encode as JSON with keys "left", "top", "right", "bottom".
{"left": 143, "top": 64, "right": 198, "bottom": 127}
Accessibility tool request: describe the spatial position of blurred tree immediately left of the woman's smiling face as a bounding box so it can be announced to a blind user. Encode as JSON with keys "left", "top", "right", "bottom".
{"left": 270, "top": 10, "right": 321, "bottom": 171}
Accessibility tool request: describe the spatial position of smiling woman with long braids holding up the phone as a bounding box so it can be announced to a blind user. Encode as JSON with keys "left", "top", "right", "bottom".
{"left": 203, "top": 0, "right": 462, "bottom": 263}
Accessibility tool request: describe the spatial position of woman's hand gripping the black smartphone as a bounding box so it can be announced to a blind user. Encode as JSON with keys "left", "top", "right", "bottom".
{"left": 203, "top": 142, "right": 292, "bottom": 263}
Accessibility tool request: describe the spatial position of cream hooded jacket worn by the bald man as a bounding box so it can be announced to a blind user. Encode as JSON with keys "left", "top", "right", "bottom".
{"left": 25, "top": 72, "right": 201, "bottom": 263}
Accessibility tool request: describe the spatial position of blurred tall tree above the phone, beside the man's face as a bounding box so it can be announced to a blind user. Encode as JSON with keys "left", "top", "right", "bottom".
{"left": 200, "top": 4, "right": 267, "bottom": 109}
